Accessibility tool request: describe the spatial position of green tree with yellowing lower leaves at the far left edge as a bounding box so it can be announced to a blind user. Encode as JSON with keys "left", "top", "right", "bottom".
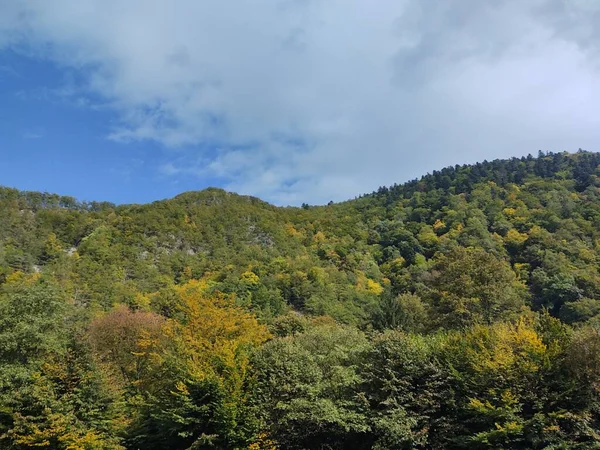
{"left": 0, "top": 274, "right": 123, "bottom": 450}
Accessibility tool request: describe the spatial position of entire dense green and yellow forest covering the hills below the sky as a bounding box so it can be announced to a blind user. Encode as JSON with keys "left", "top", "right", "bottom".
{"left": 0, "top": 151, "right": 600, "bottom": 450}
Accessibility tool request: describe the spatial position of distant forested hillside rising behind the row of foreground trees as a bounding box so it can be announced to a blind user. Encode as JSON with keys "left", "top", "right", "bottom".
{"left": 0, "top": 152, "right": 600, "bottom": 325}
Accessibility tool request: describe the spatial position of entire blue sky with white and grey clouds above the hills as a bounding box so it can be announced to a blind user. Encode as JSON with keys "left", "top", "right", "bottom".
{"left": 0, "top": 0, "right": 600, "bottom": 205}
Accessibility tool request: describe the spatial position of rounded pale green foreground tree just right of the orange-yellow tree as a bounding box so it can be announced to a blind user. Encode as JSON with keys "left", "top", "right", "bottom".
{"left": 254, "top": 324, "right": 368, "bottom": 449}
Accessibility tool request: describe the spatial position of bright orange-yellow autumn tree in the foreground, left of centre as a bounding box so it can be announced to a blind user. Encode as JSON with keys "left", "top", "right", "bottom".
{"left": 129, "top": 280, "right": 269, "bottom": 449}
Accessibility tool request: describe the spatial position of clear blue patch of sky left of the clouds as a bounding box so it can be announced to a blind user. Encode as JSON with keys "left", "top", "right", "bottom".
{"left": 0, "top": 50, "right": 222, "bottom": 203}
